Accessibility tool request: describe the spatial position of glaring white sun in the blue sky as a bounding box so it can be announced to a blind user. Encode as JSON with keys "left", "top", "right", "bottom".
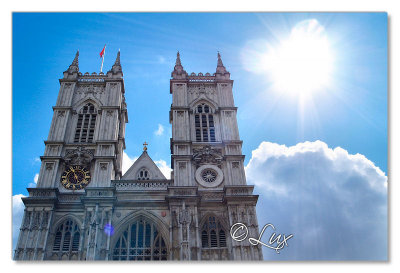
{"left": 260, "top": 19, "right": 333, "bottom": 94}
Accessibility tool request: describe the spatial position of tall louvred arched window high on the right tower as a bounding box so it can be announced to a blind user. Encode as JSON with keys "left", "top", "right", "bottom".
{"left": 194, "top": 103, "right": 215, "bottom": 142}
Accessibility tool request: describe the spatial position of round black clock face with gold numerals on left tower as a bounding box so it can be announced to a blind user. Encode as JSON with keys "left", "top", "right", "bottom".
{"left": 61, "top": 165, "right": 90, "bottom": 190}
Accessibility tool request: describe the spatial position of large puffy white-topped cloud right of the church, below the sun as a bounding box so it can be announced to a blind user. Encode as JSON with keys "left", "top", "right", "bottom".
{"left": 246, "top": 141, "right": 387, "bottom": 260}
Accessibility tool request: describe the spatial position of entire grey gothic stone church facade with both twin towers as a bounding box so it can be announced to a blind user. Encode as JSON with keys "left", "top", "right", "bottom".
{"left": 14, "top": 52, "right": 262, "bottom": 260}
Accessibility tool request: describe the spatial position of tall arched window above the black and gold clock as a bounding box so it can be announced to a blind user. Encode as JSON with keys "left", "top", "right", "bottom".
{"left": 74, "top": 103, "right": 97, "bottom": 143}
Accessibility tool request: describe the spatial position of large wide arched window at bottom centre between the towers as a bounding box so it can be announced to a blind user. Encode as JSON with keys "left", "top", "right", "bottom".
{"left": 112, "top": 218, "right": 168, "bottom": 261}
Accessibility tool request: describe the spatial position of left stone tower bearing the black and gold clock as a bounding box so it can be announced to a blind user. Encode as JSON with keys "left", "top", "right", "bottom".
{"left": 15, "top": 51, "right": 128, "bottom": 260}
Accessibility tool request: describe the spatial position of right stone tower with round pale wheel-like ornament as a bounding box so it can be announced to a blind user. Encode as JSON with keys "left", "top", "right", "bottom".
{"left": 169, "top": 52, "right": 262, "bottom": 260}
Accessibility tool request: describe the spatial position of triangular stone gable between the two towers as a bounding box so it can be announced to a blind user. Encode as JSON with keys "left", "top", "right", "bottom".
{"left": 121, "top": 151, "right": 167, "bottom": 180}
